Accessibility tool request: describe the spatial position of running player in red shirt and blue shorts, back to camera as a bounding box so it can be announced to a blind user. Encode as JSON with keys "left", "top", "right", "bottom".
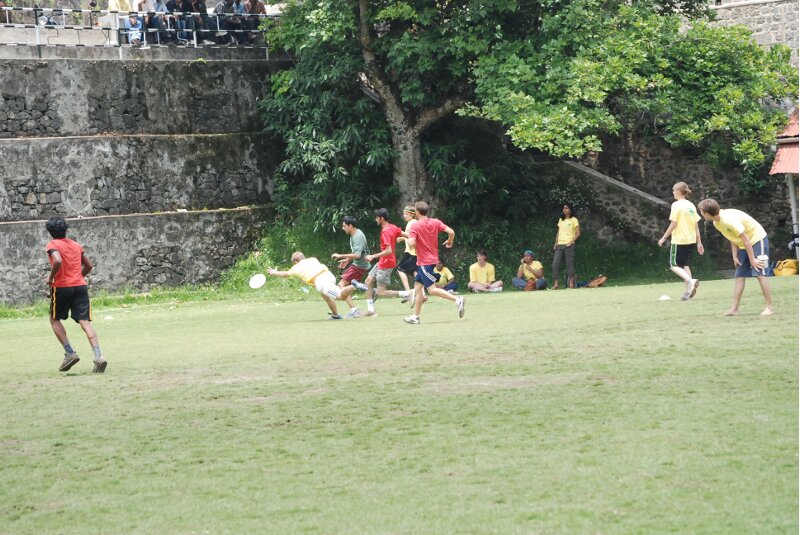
{"left": 404, "top": 201, "right": 466, "bottom": 324}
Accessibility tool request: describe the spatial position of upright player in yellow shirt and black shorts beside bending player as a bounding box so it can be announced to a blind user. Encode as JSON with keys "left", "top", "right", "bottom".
{"left": 658, "top": 182, "right": 703, "bottom": 301}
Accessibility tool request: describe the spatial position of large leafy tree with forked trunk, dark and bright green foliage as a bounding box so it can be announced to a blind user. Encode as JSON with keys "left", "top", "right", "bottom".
{"left": 262, "top": 0, "right": 797, "bottom": 213}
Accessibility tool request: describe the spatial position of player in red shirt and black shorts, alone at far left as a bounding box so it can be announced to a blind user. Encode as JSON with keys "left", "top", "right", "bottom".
{"left": 45, "top": 217, "right": 108, "bottom": 373}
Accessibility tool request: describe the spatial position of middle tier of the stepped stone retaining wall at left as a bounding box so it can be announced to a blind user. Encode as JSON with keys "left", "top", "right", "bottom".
{"left": 0, "top": 134, "right": 281, "bottom": 221}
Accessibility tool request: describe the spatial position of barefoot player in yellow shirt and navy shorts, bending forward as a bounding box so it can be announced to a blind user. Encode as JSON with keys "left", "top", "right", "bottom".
{"left": 697, "top": 199, "right": 773, "bottom": 316}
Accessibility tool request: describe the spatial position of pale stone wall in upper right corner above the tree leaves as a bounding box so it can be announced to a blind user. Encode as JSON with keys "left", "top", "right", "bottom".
{"left": 711, "top": 0, "right": 800, "bottom": 67}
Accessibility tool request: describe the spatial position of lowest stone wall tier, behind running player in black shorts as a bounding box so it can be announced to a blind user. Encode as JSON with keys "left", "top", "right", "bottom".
{"left": 0, "top": 208, "right": 271, "bottom": 305}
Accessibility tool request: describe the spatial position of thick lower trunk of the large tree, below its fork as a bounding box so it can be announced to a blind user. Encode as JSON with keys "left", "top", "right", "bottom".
{"left": 391, "top": 127, "right": 431, "bottom": 204}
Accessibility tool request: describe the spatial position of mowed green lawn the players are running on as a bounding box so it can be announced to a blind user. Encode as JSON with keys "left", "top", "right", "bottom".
{"left": 0, "top": 277, "right": 798, "bottom": 534}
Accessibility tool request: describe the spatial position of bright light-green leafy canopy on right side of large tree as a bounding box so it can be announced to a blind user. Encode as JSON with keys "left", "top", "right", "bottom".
{"left": 468, "top": 0, "right": 798, "bottom": 190}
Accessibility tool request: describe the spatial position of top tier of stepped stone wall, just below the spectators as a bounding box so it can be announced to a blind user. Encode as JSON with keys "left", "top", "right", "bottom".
{"left": 0, "top": 60, "right": 270, "bottom": 137}
